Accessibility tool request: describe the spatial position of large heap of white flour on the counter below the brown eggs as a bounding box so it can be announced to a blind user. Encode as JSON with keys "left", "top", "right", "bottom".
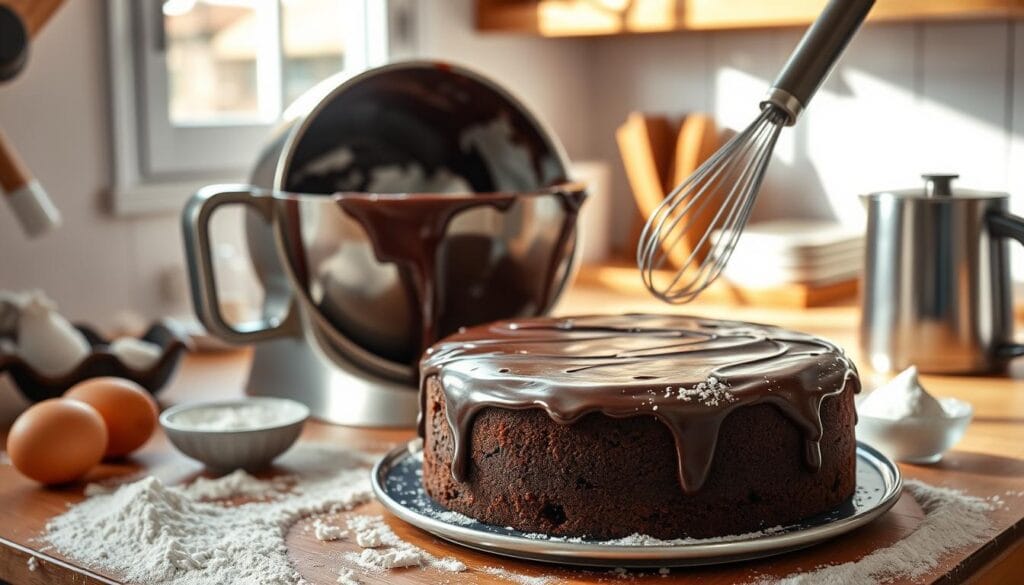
{"left": 44, "top": 446, "right": 373, "bottom": 585}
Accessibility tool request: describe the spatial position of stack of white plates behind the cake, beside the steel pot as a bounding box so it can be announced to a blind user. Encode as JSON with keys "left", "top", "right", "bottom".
{"left": 722, "top": 220, "right": 864, "bottom": 288}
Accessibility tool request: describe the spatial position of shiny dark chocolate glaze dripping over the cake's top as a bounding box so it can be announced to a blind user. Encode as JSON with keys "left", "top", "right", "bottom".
{"left": 420, "top": 315, "right": 859, "bottom": 493}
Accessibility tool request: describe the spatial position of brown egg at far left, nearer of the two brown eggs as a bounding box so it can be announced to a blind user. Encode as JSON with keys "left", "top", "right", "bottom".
{"left": 7, "top": 399, "right": 106, "bottom": 484}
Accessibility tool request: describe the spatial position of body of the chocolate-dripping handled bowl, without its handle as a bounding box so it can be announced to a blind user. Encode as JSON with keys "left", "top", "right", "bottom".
{"left": 283, "top": 184, "right": 585, "bottom": 376}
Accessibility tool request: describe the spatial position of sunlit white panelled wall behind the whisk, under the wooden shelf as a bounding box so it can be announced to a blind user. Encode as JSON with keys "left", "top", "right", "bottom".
{"left": 592, "top": 23, "right": 1024, "bottom": 249}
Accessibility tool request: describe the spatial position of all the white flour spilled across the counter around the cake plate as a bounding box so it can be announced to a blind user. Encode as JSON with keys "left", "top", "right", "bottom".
{"left": 39, "top": 446, "right": 999, "bottom": 585}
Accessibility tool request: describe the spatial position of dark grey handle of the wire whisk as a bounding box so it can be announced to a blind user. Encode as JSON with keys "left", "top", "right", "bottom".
{"left": 761, "top": 0, "right": 874, "bottom": 126}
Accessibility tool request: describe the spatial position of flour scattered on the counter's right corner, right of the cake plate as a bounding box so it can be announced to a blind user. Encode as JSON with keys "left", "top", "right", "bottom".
{"left": 755, "top": 479, "right": 998, "bottom": 585}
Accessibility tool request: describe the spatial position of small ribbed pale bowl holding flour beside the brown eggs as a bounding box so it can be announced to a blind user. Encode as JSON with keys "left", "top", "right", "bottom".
{"left": 160, "top": 396, "right": 309, "bottom": 471}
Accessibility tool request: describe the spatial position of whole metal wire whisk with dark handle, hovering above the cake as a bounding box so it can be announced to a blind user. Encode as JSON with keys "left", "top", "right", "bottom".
{"left": 637, "top": 0, "right": 874, "bottom": 303}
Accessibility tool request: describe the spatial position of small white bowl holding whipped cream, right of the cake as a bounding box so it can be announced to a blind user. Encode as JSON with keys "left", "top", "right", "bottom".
{"left": 857, "top": 398, "right": 974, "bottom": 463}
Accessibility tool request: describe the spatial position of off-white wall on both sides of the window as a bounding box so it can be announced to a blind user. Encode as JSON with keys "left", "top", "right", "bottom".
{"left": 0, "top": 0, "right": 589, "bottom": 326}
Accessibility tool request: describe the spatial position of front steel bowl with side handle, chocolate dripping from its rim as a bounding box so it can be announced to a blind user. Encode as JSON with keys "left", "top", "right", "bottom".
{"left": 184, "top": 183, "right": 586, "bottom": 380}
